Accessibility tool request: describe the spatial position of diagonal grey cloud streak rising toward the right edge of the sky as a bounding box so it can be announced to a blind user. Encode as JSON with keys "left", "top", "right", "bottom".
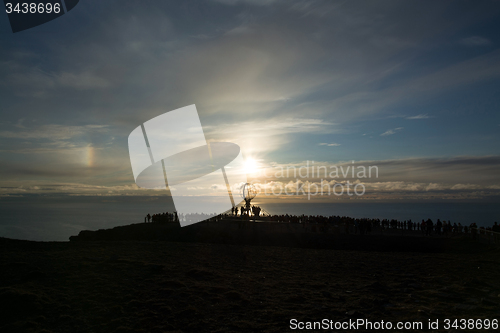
{"left": 306, "top": 50, "right": 500, "bottom": 122}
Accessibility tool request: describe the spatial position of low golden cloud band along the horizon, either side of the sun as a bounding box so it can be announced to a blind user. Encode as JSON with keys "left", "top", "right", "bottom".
{"left": 0, "top": 156, "right": 500, "bottom": 200}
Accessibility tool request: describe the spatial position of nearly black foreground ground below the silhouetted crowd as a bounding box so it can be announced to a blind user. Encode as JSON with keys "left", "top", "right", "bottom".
{"left": 0, "top": 223, "right": 500, "bottom": 332}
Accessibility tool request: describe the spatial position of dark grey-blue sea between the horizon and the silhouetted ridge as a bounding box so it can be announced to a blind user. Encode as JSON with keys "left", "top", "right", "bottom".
{"left": 0, "top": 196, "right": 500, "bottom": 241}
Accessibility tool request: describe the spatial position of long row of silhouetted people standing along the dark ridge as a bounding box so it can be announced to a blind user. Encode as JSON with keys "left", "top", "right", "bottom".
{"left": 144, "top": 206, "right": 500, "bottom": 238}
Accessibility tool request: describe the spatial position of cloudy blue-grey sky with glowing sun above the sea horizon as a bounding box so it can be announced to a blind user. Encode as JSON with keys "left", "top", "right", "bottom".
{"left": 0, "top": 0, "right": 500, "bottom": 200}
